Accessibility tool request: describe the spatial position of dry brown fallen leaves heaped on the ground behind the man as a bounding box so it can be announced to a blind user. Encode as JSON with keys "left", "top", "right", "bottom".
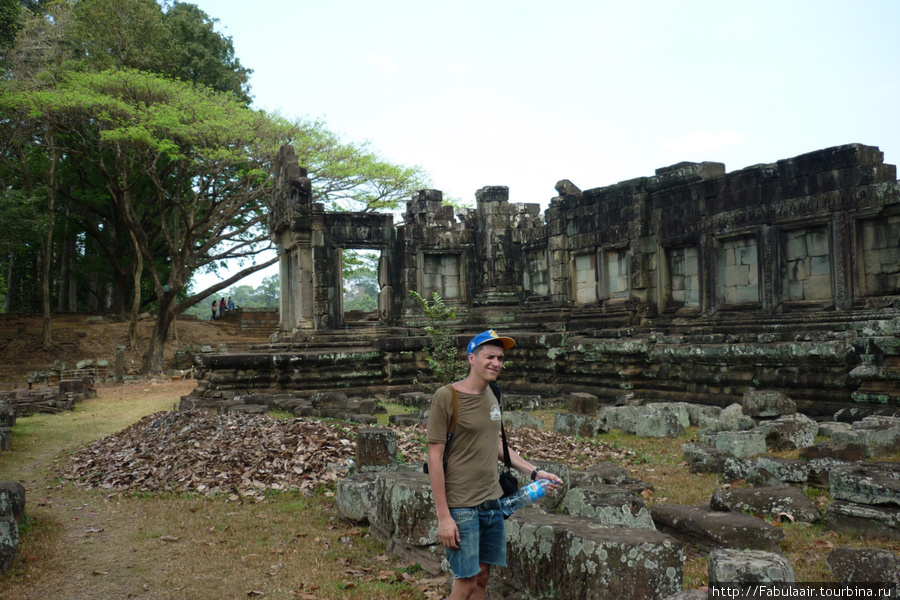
{"left": 63, "top": 412, "right": 633, "bottom": 500}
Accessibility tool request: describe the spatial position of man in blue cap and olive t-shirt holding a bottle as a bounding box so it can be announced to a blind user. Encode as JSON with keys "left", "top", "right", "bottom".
{"left": 426, "top": 330, "right": 562, "bottom": 600}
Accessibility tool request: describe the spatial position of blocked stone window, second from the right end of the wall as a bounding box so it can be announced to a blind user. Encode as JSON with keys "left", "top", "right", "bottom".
{"left": 781, "top": 227, "right": 834, "bottom": 302}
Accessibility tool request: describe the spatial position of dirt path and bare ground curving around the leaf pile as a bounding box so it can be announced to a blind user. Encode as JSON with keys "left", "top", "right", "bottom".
{"left": 0, "top": 381, "right": 428, "bottom": 600}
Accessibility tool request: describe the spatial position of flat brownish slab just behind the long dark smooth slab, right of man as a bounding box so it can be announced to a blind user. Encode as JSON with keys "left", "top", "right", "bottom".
{"left": 709, "top": 485, "right": 821, "bottom": 523}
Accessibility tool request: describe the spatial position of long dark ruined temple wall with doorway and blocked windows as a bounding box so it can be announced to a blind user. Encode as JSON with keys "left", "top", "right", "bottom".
{"left": 189, "top": 144, "right": 900, "bottom": 416}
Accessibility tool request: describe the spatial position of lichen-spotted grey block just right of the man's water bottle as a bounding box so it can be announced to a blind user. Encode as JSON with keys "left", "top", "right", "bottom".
{"left": 559, "top": 485, "right": 656, "bottom": 529}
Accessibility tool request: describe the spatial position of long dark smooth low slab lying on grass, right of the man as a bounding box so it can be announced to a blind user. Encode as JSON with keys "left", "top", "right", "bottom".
{"left": 650, "top": 504, "right": 784, "bottom": 550}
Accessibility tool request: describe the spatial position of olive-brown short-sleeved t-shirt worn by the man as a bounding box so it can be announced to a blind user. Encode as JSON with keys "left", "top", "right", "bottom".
{"left": 425, "top": 386, "right": 503, "bottom": 508}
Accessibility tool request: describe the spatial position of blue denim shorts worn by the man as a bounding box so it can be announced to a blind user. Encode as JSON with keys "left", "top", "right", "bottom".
{"left": 444, "top": 508, "right": 506, "bottom": 579}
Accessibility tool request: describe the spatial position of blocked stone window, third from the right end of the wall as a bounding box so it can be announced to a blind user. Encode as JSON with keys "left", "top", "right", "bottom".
{"left": 716, "top": 237, "right": 759, "bottom": 306}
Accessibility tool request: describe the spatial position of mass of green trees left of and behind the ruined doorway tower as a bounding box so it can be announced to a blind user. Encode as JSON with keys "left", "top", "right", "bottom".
{"left": 0, "top": 0, "right": 428, "bottom": 371}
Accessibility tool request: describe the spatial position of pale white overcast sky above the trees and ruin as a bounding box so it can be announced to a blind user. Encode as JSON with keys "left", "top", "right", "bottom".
{"left": 188, "top": 0, "right": 900, "bottom": 290}
